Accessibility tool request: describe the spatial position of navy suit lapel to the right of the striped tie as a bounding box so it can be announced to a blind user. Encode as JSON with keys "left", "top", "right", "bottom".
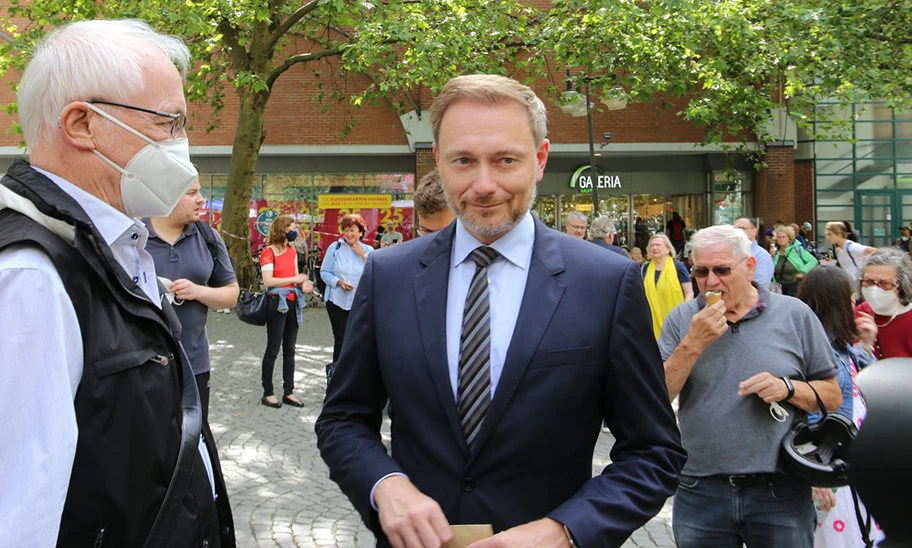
{"left": 469, "top": 218, "right": 566, "bottom": 461}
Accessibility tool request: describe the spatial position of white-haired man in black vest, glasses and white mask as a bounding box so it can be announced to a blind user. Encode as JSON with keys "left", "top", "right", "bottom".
{"left": 0, "top": 20, "right": 235, "bottom": 547}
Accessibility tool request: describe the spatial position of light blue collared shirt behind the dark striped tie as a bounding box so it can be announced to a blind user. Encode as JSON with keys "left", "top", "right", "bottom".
{"left": 446, "top": 213, "right": 535, "bottom": 400}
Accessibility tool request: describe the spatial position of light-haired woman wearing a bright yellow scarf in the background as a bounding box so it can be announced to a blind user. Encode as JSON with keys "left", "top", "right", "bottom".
{"left": 642, "top": 234, "right": 693, "bottom": 340}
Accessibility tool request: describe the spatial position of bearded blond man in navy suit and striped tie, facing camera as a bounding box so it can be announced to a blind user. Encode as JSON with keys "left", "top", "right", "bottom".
{"left": 316, "top": 75, "right": 685, "bottom": 548}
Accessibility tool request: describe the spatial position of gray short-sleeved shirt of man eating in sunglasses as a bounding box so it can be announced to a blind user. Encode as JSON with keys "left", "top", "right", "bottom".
{"left": 659, "top": 292, "right": 837, "bottom": 476}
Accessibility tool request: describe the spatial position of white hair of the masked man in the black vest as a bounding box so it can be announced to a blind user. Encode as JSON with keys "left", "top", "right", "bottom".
{"left": 16, "top": 19, "right": 190, "bottom": 146}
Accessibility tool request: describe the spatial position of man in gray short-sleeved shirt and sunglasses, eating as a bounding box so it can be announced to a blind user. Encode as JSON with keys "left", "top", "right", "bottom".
{"left": 659, "top": 225, "right": 842, "bottom": 548}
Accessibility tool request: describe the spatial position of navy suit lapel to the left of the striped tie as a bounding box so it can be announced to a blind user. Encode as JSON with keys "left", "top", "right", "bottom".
{"left": 415, "top": 223, "right": 467, "bottom": 453}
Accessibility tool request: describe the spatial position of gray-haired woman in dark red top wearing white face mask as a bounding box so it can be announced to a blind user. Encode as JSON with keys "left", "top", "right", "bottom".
{"left": 855, "top": 247, "right": 912, "bottom": 359}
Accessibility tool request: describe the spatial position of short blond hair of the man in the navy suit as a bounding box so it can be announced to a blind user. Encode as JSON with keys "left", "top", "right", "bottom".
{"left": 431, "top": 74, "right": 548, "bottom": 147}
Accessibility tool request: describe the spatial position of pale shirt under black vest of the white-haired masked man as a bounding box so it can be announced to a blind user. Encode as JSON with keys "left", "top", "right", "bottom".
{"left": 0, "top": 169, "right": 215, "bottom": 546}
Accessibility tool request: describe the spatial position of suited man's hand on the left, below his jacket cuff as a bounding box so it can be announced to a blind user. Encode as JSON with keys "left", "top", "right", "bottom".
{"left": 374, "top": 476, "right": 453, "bottom": 548}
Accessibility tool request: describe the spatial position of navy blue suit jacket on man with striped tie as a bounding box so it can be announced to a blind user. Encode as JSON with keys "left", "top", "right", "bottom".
{"left": 316, "top": 219, "right": 685, "bottom": 548}
